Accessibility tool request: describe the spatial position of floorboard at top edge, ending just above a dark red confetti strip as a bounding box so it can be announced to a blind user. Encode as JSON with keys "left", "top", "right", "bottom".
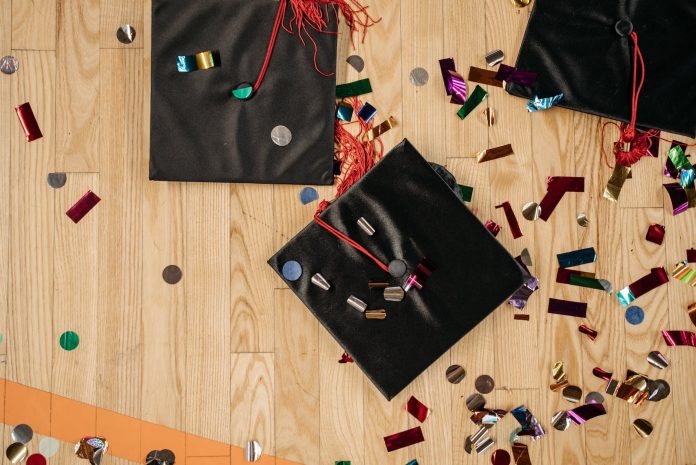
{"left": 56, "top": 0, "right": 99, "bottom": 171}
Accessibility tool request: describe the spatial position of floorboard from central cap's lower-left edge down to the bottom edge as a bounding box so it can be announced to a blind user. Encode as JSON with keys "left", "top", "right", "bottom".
{"left": 274, "top": 289, "right": 320, "bottom": 465}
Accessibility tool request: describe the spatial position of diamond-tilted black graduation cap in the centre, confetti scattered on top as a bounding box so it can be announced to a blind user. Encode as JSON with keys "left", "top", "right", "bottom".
{"left": 268, "top": 140, "right": 522, "bottom": 399}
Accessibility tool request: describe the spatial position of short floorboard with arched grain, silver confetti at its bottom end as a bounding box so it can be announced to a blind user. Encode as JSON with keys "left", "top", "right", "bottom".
{"left": 230, "top": 353, "right": 275, "bottom": 455}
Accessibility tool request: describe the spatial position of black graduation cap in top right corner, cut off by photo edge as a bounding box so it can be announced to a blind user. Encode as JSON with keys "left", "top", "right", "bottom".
{"left": 507, "top": 0, "right": 696, "bottom": 137}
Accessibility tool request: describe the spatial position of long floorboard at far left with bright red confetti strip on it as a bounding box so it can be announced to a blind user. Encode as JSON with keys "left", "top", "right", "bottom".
{"left": 7, "top": 50, "right": 58, "bottom": 390}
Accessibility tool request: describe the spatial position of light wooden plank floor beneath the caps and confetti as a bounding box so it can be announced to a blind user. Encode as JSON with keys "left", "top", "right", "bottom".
{"left": 0, "top": 0, "right": 696, "bottom": 465}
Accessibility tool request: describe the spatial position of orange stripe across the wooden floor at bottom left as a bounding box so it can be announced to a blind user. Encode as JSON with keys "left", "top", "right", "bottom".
{"left": 0, "top": 378, "right": 301, "bottom": 465}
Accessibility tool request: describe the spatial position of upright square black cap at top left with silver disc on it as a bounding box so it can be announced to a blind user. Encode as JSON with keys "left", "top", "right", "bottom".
{"left": 150, "top": 0, "right": 336, "bottom": 184}
